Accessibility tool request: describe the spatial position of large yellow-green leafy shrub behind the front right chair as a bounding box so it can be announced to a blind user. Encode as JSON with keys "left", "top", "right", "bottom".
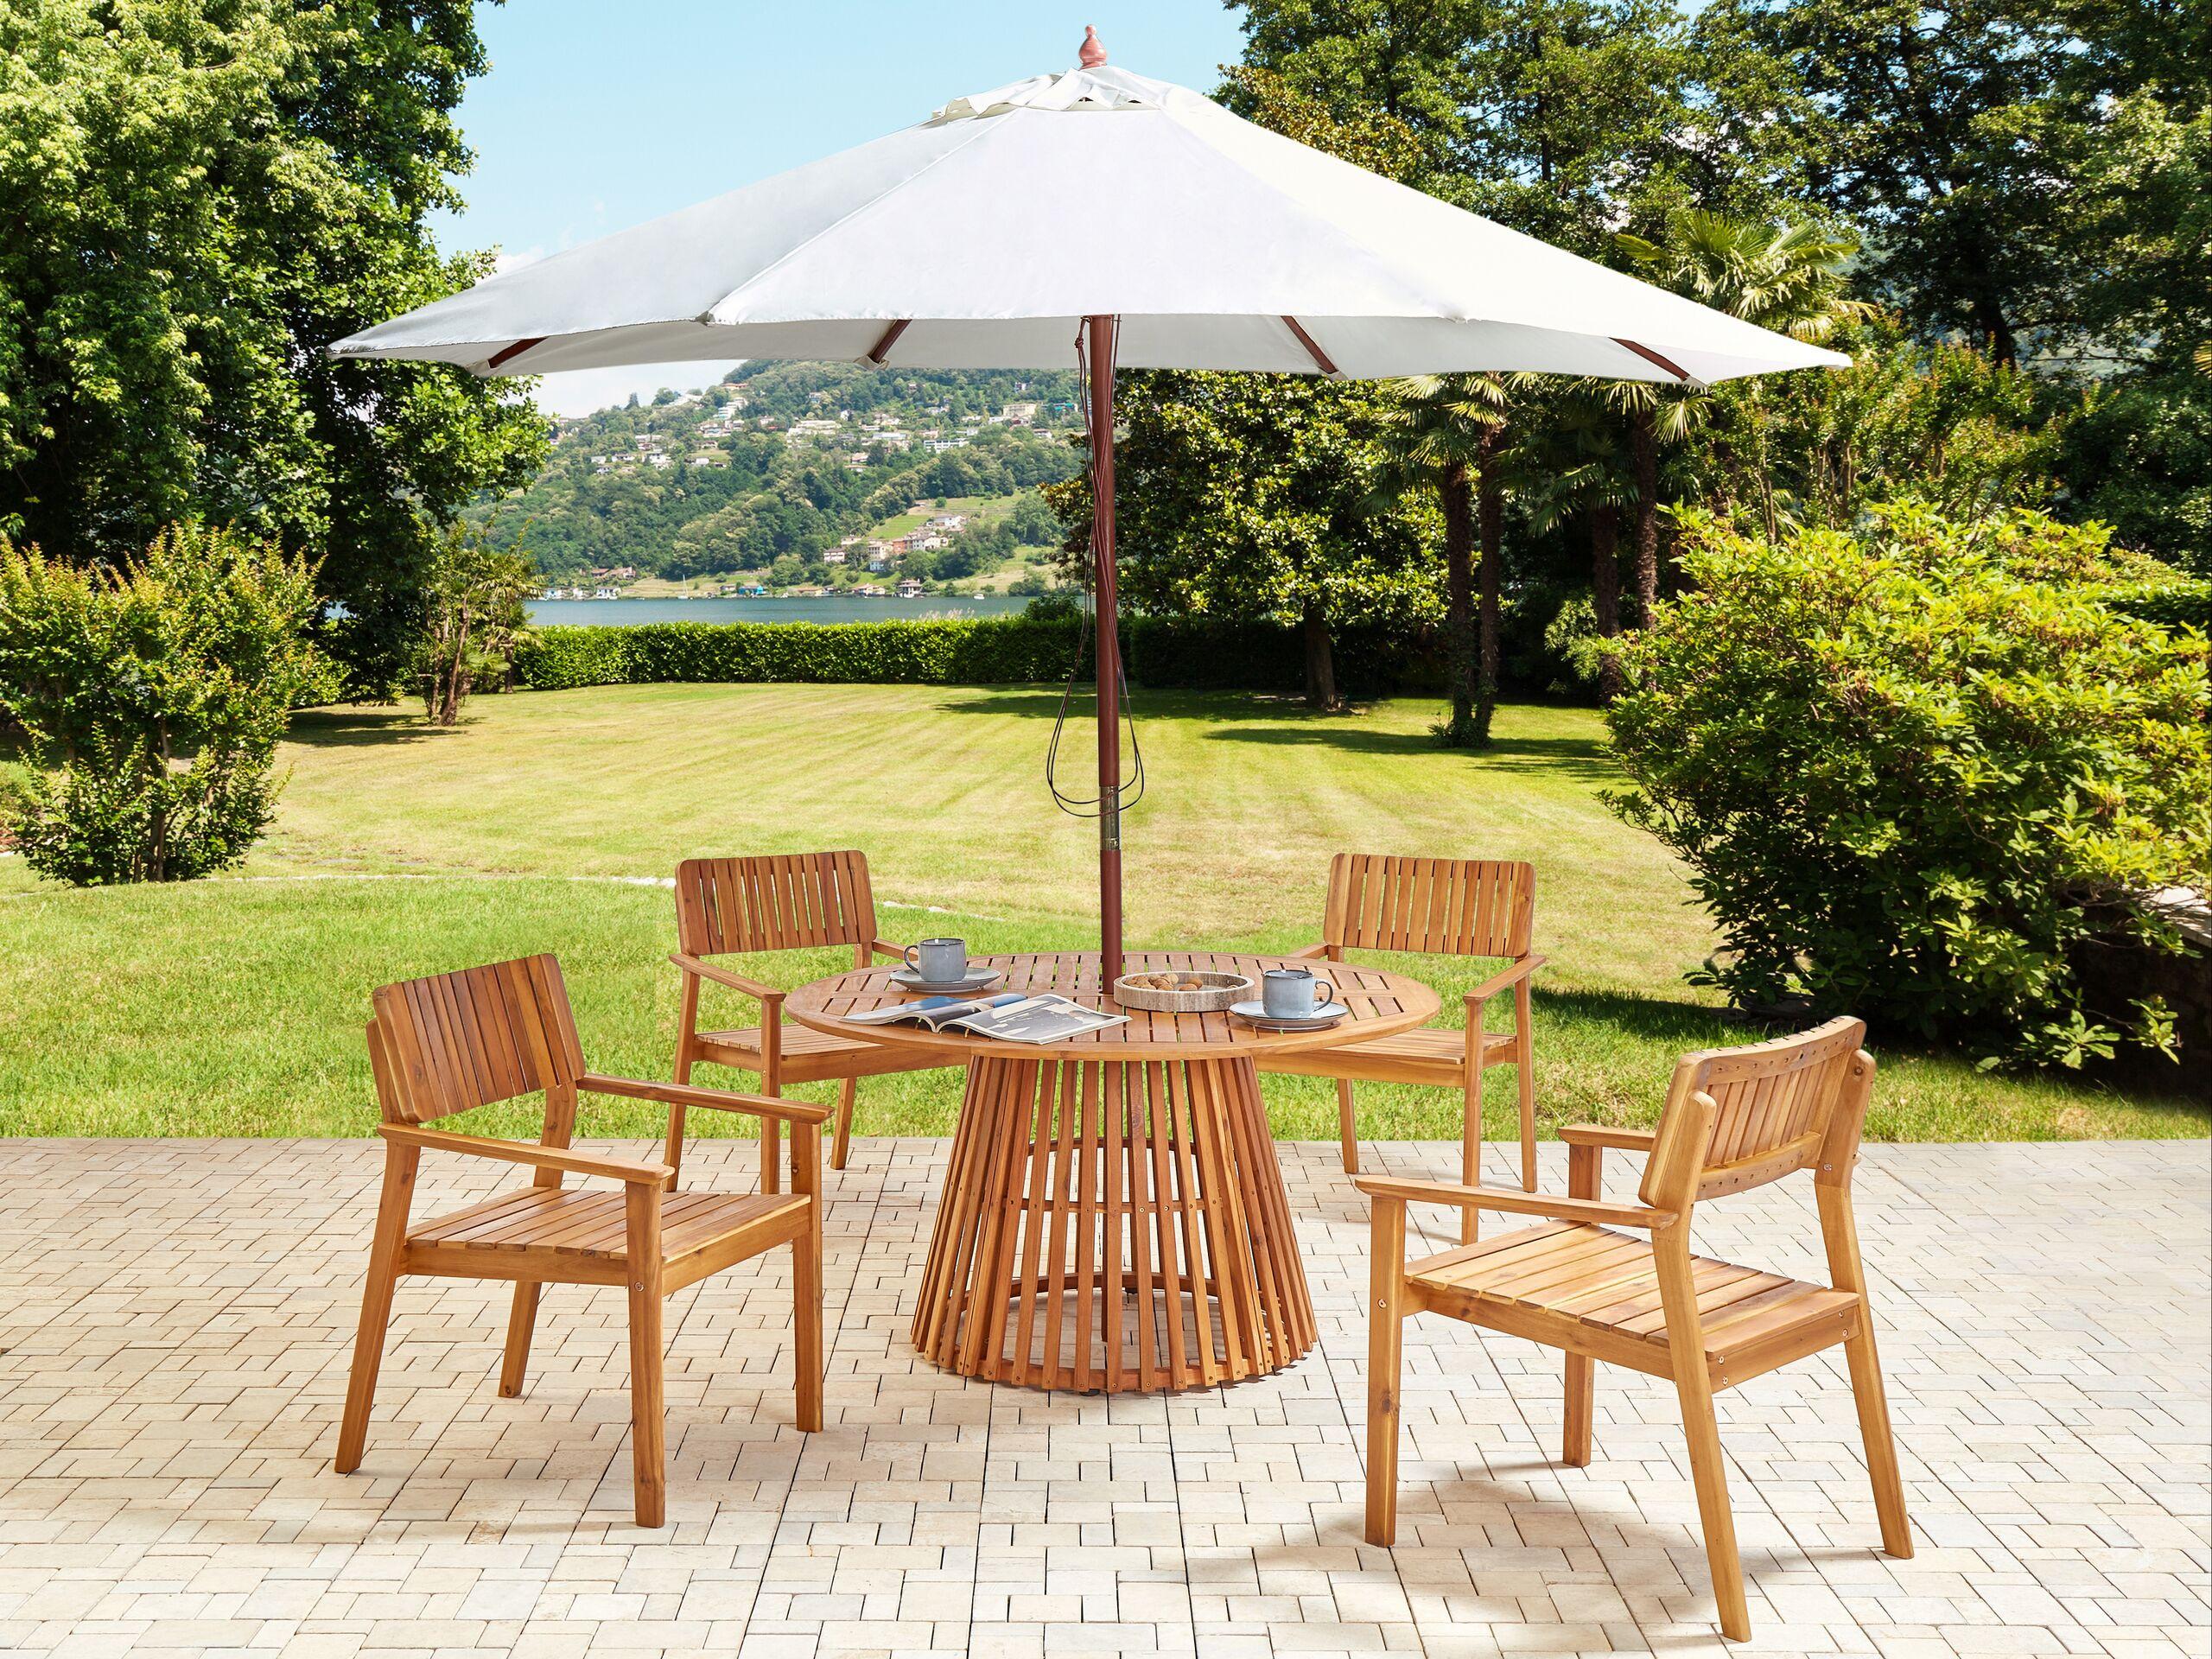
{"left": 1611, "top": 506, "right": 2212, "bottom": 1064}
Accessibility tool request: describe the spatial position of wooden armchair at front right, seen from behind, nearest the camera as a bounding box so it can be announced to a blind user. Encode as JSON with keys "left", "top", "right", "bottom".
{"left": 1356, "top": 1020, "right": 1913, "bottom": 1642}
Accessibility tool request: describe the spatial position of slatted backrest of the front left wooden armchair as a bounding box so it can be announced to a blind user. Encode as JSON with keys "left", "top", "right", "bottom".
{"left": 370, "top": 956, "right": 584, "bottom": 1123}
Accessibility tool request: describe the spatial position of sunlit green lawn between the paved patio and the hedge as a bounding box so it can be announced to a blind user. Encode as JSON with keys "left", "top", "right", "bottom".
{"left": 0, "top": 686, "right": 2208, "bottom": 1139}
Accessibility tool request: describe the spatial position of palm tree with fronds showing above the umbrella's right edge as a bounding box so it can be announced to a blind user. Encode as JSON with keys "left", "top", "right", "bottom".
{"left": 1611, "top": 208, "right": 1876, "bottom": 624}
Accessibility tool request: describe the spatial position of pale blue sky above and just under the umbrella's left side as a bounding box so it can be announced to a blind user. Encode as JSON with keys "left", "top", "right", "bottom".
{"left": 435, "top": 0, "right": 1241, "bottom": 414}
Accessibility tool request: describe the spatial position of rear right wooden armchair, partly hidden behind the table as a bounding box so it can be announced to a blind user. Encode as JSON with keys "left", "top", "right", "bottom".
{"left": 1259, "top": 852, "right": 1544, "bottom": 1241}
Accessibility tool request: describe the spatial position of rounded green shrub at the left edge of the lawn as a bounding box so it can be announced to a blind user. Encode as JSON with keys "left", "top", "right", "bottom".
{"left": 0, "top": 524, "right": 325, "bottom": 885}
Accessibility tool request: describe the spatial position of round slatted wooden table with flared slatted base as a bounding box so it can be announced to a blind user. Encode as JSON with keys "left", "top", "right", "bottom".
{"left": 783, "top": 951, "right": 1438, "bottom": 1391}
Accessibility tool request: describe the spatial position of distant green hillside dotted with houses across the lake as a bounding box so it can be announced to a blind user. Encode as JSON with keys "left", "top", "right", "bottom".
{"left": 474, "top": 363, "right": 1082, "bottom": 597}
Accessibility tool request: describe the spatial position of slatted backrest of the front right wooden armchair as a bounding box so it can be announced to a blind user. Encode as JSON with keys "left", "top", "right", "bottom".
{"left": 1643, "top": 1020, "right": 1873, "bottom": 1205}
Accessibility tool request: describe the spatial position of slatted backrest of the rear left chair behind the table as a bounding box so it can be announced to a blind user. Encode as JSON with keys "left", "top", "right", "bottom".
{"left": 677, "top": 852, "right": 876, "bottom": 956}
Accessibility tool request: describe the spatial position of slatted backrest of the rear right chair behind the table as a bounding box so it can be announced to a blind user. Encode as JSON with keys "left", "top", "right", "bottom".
{"left": 1320, "top": 852, "right": 1535, "bottom": 957}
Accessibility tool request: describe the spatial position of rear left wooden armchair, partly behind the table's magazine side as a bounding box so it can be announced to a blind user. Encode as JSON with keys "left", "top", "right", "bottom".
{"left": 666, "top": 852, "right": 944, "bottom": 1192}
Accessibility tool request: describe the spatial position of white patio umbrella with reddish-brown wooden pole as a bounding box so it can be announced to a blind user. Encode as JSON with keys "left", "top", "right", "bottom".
{"left": 329, "top": 31, "right": 1849, "bottom": 984}
